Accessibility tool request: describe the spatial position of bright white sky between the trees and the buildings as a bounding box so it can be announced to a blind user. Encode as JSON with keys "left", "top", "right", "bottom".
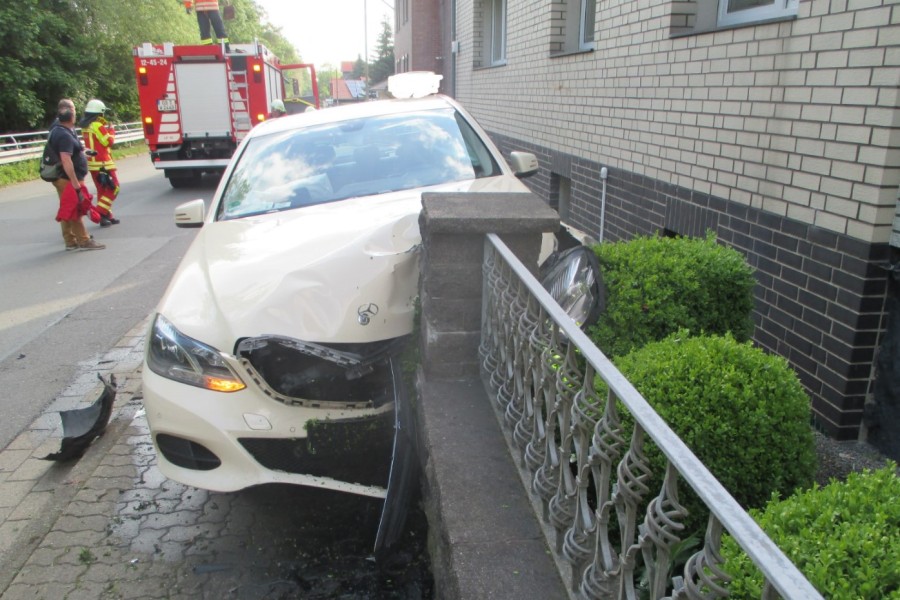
{"left": 256, "top": 0, "right": 395, "bottom": 70}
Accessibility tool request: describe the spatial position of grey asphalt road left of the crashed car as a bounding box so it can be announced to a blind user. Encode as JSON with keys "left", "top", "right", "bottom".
{"left": 0, "top": 155, "right": 209, "bottom": 448}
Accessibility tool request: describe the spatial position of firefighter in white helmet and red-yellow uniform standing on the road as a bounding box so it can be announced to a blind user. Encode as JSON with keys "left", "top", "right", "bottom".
{"left": 79, "top": 99, "right": 119, "bottom": 227}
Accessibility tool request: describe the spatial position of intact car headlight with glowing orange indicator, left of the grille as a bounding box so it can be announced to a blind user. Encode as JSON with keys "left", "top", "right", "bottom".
{"left": 147, "top": 314, "right": 247, "bottom": 392}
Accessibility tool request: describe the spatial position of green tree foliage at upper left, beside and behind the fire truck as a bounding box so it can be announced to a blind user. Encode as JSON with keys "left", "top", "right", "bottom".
{"left": 0, "top": 0, "right": 310, "bottom": 132}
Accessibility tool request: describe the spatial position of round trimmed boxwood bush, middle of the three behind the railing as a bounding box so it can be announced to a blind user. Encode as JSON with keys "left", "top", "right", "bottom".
{"left": 597, "top": 331, "right": 816, "bottom": 538}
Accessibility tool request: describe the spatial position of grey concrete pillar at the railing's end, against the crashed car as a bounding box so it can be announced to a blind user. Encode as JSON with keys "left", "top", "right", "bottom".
{"left": 419, "top": 193, "right": 559, "bottom": 380}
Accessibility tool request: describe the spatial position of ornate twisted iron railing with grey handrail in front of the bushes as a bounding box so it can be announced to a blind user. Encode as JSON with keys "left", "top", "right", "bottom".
{"left": 480, "top": 235, "right": 821, "bottom": 600}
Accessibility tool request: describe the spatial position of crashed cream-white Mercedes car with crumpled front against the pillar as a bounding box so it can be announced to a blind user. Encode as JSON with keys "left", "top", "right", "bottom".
{"left": 143, "top": 77, "right": 537, "bottom": 548}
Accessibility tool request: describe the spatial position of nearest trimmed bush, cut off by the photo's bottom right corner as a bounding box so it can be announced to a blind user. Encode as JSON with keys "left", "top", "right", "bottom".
{"left": 722, "top": 463, "right": 900, "bottom": 600}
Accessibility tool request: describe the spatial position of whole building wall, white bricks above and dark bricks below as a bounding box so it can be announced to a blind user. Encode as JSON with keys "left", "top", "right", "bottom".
{"left": 456, "top": 0, "right": 900, "bottom": 439}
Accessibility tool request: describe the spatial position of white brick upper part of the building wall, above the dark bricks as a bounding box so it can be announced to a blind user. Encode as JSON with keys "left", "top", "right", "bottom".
{"left": 456, "top": 0, "right": 900, "bottom": 243}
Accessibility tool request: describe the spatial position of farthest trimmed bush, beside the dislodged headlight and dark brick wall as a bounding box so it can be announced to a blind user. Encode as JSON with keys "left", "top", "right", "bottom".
{"left": 589, "top": 233, "right": 756, "bottom": 357}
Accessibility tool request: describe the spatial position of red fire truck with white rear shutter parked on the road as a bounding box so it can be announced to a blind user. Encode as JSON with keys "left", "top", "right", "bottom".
{"left": 134, "top": 42, "right": 319, "bottom": 188}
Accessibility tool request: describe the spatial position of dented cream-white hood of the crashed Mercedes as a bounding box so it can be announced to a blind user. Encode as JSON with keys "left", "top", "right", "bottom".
{"left": 158, "top": 177, "right": 527, "bottom": 352}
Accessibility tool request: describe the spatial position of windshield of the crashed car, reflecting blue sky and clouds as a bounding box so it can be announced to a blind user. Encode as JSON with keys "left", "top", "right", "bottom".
{"left": 216, "top": 107, "right": 500, "bottom": 220}
